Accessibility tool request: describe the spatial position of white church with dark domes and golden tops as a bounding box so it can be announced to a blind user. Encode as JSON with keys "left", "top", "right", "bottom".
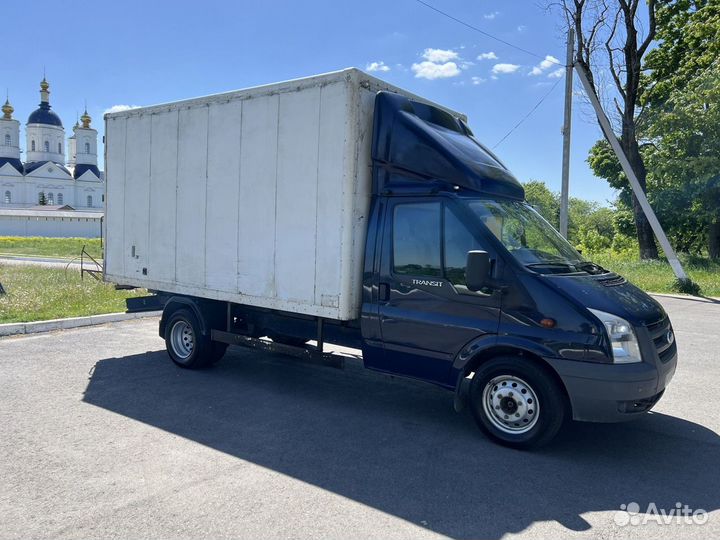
{"left": 0, "top": 78, "right": 105, "bottom": 212}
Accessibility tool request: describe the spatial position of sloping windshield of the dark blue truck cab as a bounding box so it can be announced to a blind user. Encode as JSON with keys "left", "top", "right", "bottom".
{"left": 468, "top": 199, "right": 591, "bottom": 272}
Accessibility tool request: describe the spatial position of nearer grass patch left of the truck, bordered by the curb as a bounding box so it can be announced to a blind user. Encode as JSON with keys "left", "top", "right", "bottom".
{"left": 0, "top": 263, "right": 147, "bottom": 323}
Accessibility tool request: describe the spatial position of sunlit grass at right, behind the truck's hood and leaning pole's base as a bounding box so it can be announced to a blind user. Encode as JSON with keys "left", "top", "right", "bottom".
{"left": 586, "top": 252, "right": 720, "bottom": 297}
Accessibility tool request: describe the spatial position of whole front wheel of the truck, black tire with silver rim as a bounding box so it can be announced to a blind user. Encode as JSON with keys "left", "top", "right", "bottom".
{"left": 470, "top": 356, "right": 569, "bottom": 450}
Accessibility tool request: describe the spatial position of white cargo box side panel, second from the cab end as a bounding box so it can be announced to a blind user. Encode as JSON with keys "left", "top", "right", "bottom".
{"left": 275, "top": 87, "right": 320, "bottom": 306}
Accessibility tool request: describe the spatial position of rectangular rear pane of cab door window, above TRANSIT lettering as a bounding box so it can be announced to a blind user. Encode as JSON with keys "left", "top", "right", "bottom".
{"left": 393, "top": 202, "right": 442, "bottom": 277}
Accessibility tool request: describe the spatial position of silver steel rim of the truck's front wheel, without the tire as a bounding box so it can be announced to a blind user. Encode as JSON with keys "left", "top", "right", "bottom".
{"left": 482, "top": 375, "right": 540, "bottom": 435}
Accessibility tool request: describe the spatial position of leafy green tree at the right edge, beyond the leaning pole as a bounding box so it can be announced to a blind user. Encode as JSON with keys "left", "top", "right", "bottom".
{"left": 643, "top": 0, "right": 720, "bottom": 257}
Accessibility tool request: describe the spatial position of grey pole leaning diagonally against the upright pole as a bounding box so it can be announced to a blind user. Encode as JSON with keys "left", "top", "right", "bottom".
{"left": 575, "top": 63, "right": 688, "bottom": 280}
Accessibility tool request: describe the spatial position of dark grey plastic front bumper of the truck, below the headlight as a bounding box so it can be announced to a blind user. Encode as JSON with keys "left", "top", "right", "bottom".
{"left": 546, "top": 344, "right": 677, "bottom": 422}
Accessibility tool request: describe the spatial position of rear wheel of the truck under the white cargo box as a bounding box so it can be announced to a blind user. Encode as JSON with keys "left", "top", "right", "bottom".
{"left": 165, "top": 309, "right": 215, "bottom": 369}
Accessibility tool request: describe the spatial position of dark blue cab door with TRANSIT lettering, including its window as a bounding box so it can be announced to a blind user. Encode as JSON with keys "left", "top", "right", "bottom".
{"left": 374, "top": 197, "right": 501, "bottom": 385}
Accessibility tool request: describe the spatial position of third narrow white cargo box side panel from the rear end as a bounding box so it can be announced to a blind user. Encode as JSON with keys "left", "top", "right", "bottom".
{"left": 148, "top": 110, "right": 178, "bottom": 283}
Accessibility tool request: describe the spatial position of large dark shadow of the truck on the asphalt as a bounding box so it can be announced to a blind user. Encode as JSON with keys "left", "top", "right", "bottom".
{"left": 84, "top": 348, "right": 720, "bottom": 538}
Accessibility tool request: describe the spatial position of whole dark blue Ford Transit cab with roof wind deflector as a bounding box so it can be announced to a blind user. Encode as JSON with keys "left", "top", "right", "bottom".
{"left": 362, "top": 94, "right": 677, "bottom": 447}
